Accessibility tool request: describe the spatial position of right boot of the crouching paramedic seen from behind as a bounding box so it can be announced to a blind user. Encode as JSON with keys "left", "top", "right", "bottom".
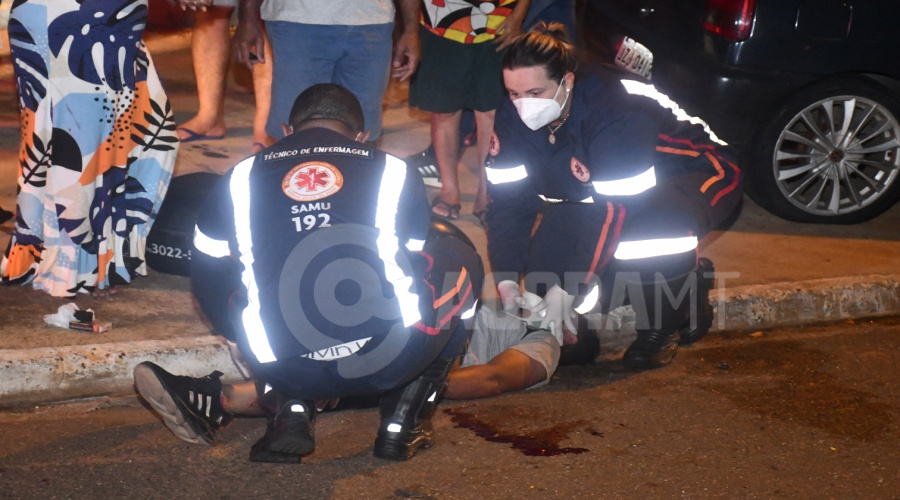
{"left": 374, "top": 358, "right": 456, "bottom": 461}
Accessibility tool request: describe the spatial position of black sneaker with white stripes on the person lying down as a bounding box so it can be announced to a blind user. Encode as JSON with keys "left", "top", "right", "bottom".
{"left": 134, "top": 361, "right": 234, "bottom": 446}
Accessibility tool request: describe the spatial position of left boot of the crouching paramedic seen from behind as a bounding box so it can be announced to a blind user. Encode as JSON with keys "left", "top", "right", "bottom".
{"left": 250, "top": 388, "right": 316, "bottom": 463}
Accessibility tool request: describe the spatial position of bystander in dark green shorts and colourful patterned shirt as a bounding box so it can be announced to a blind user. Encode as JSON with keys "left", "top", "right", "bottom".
{"left": 409, "top": 0, "right": 530, "bottom": 225}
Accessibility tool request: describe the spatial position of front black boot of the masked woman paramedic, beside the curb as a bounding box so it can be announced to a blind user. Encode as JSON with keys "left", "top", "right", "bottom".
{"left": 622, "top": 274, "right": 692, "bottom": 370}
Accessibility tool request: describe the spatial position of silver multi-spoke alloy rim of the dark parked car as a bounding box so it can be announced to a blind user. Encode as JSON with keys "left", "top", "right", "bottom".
{"left": 773, "top": 95, "right": 900, "bottom": 216}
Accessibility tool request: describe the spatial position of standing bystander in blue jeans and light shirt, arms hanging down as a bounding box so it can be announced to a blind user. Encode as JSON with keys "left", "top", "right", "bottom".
{"left": 232, "top": 0, "right": 419, "bottom": 140}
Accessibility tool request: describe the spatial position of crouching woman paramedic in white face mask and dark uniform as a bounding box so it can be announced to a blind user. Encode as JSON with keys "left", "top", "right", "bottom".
{"left": 487, "top": 23, "right": 741, "bottom": 369}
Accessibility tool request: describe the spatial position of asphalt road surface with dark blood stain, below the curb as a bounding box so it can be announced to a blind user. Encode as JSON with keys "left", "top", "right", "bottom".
{"left": 0, "top": 319, "right": 900, "bottom": 499}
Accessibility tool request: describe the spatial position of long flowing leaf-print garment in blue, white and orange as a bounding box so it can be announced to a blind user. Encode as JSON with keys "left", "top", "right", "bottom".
{"left": 0, "top": 0, "right": 178, "bottom": 296}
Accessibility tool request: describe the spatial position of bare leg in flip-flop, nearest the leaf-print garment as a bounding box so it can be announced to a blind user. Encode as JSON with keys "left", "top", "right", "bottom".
{"left": 178, "top": 7, "right": 234, "bottom": 140}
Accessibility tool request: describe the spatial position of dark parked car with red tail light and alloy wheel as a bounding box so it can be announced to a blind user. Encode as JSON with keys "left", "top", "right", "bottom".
{"left": 584, "top": 0, "right": 900, "bottom": 224}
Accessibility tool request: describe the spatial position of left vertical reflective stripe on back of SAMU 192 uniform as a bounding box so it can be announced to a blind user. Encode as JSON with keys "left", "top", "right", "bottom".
{"left": 229, "top": 157, "right": 276, "bottom": 363}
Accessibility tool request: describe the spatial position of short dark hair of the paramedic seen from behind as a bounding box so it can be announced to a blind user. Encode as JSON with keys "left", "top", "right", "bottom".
{"left": 290, "top": 83, "right": 365, "bottom": 132}
